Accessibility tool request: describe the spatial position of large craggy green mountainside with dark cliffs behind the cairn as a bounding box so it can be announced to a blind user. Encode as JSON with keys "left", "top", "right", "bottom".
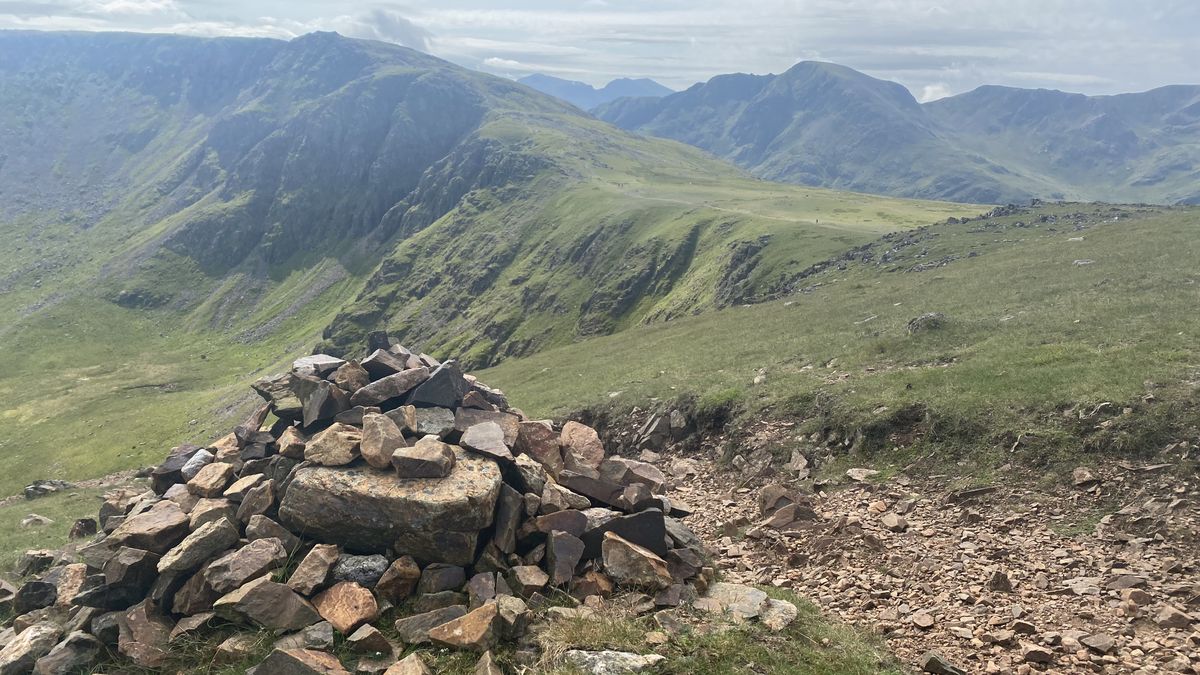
{"left": 0, "top": 32, "right": 965, "bottom": 494}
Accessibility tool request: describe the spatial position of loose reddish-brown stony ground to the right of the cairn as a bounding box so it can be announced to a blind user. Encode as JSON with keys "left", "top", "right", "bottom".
{"left": 662, "top": 429, "right": 1200, "bottom": 673}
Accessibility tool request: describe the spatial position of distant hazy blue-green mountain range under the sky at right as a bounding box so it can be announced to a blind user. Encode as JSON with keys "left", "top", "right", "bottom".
{"left": 595, "top": 62, "right": 1200, "bottom": 203}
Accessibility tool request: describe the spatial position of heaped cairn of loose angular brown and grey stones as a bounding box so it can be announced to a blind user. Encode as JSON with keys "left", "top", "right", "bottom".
{"left": 0, "top": 335, "right": 720, "bottom": 675}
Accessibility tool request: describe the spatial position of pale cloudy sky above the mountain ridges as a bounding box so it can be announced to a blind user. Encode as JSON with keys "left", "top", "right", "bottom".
{"left": 0, "top": 0, "right": 1200, "bottom": 101}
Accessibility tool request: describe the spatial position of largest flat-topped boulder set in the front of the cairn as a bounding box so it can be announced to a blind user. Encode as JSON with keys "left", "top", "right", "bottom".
{"left": 280, "top": 448, "right": 500, "bottom": 566}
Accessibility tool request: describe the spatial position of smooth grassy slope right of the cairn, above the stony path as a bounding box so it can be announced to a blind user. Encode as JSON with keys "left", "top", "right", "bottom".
{"left": 480, "top": 200, "right": 1200, "bottom": 461}
